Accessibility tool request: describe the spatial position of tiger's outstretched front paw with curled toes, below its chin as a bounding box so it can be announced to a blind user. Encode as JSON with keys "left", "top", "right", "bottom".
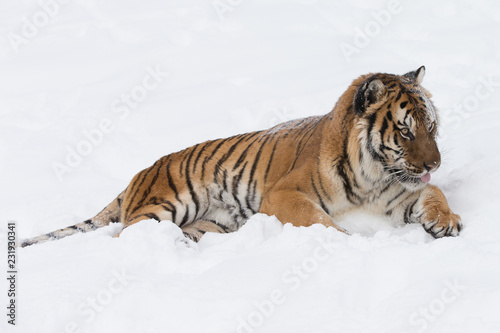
{"left": 422, "top": 208, "right": 463, "bottom": 238}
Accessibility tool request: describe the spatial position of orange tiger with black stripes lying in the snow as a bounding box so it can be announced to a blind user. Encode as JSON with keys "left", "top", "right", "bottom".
{"left": 21, "top": 66, "right": 462, "bottom": 247}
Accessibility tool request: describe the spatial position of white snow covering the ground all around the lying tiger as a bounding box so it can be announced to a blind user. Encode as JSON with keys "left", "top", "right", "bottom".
{"left": 0, "top": 0, "right": 500, "bottom": 333}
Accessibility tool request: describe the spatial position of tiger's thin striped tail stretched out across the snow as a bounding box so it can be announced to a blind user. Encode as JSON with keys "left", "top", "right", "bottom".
{"left": 18, "top": 191, "right": 125, "bottom": 247}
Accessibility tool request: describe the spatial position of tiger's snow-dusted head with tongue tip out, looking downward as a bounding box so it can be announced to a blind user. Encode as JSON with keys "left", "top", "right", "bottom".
{"left": 353, "top": 66, "right": 441, "bottom": 190}
